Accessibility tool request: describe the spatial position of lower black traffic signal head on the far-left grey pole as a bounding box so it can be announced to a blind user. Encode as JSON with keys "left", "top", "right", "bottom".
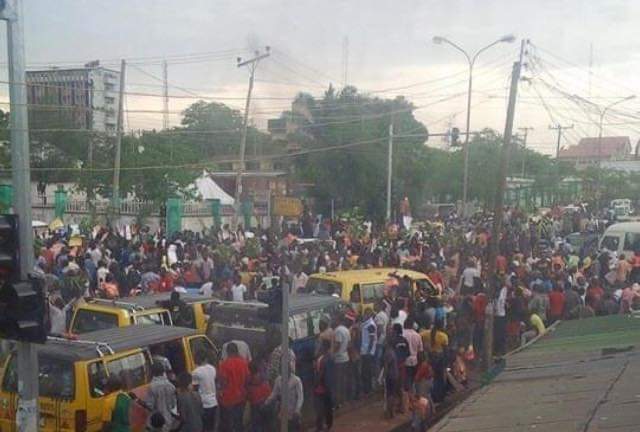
{"left": 0, "top": 279, "right": 49, "bottom": 343}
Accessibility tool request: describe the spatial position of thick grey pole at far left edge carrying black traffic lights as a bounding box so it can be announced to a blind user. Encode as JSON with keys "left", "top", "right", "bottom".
{"left": 0, "top": 0, "right": 39, "bottom": 432}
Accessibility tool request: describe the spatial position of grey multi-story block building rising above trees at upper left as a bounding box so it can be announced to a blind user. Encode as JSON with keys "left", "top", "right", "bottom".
{"left": 26, "top": 61, "right": 120, "bottom": 133}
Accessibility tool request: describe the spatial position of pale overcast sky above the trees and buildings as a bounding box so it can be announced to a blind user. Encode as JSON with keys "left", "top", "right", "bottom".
{"left": 0, "top": 0, "right": 640, "bottom": 153}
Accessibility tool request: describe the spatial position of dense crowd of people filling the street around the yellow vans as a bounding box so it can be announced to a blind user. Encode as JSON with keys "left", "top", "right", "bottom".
{"left": 34, "top": 203, "right": 640, "bottom": 431}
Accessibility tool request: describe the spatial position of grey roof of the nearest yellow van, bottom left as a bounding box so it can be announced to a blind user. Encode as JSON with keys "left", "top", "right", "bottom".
{"left": 37, "top": 325, "right": 197, "bottom": 362}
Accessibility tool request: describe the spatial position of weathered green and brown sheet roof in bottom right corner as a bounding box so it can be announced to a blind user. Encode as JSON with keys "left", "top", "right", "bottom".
{"left": 431, "top": 316, "right": 640, "bottom": 432}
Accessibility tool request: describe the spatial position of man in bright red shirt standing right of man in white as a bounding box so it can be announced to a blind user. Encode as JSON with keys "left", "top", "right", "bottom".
{"left": 218, "top": 342, "right": 249, "bottom": 432}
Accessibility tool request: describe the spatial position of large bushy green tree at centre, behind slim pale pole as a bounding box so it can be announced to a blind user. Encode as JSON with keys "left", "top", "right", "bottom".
{"left": 283, "top": 87, "right": 427, "bottom": 218}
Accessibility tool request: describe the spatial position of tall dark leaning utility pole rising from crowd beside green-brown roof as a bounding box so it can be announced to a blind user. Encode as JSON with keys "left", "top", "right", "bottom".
{"left": 484, "top": 39, "right": 528, "bottom": 369}
